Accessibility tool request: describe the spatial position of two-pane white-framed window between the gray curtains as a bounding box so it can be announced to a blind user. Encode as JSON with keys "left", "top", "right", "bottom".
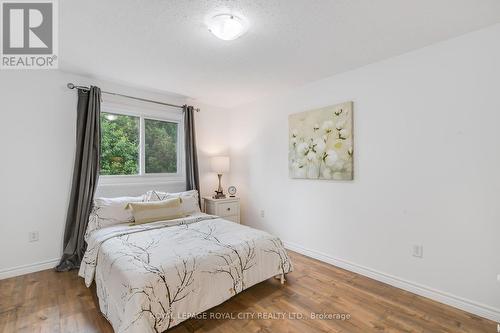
{"left": 100, "top": 107, "right": 183, "bottom": 176}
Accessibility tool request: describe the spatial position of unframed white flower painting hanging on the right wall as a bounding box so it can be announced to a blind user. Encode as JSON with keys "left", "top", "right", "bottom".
{"left": 288, "top": 102, "right": 354, "bottom": 180}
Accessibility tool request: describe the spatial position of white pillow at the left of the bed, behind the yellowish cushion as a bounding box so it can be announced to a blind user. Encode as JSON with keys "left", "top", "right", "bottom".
{"left": 85, "top": 195, "right": 145, "bottom": 237}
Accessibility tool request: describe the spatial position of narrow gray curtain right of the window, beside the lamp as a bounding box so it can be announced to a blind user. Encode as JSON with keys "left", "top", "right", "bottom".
{"left": 183, "top": 105, "right": 201, "bottom": 206}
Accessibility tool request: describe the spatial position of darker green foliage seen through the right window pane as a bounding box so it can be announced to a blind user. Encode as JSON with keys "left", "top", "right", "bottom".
{"left": 144, "top": 119, "right": 177, "bottom": 173}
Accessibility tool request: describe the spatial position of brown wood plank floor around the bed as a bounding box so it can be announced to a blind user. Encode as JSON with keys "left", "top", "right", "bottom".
{"left": 0, "top": 252, "right": 496, "bottom": 333}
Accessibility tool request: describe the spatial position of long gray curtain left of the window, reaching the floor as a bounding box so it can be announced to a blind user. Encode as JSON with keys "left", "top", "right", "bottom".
{"left": 56, "top": 87, "right": 101, "bottom": 272}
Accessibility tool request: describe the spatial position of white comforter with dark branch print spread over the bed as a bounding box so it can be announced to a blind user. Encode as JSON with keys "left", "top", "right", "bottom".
{"left": 79, "top": 213, "right": 292, "bottom": 333}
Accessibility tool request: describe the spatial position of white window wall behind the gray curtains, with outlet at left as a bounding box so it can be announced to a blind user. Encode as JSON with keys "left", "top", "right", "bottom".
{"left": 0, "top": 71, "right": 228, "bottom": 278}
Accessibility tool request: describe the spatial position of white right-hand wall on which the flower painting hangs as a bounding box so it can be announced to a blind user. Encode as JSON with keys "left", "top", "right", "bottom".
{"left": 231, "top": 25, "right": 500, "bottom": 320}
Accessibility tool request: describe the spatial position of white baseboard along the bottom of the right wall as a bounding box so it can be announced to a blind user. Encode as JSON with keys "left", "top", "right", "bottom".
{"left": 283, "top": 242, "right": 500, "bottom": 323}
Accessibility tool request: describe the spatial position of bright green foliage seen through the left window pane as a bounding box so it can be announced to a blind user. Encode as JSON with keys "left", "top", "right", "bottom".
{"left": 101, "top": 113, "right": 139, "bottom": 175}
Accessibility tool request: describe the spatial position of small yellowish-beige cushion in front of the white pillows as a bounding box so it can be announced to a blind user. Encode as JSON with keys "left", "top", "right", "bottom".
{"left": 127, "top": 198, "right": 186, "bottom": 224}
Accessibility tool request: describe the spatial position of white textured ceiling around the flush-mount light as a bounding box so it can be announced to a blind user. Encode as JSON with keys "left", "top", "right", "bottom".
{"left": 59, "top": 0, "right": 500, "bottom": 107}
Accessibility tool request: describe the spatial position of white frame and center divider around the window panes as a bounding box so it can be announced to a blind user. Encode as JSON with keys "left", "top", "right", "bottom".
{"left": 99, "top": 102, "right": 185, "bottom": 185}
